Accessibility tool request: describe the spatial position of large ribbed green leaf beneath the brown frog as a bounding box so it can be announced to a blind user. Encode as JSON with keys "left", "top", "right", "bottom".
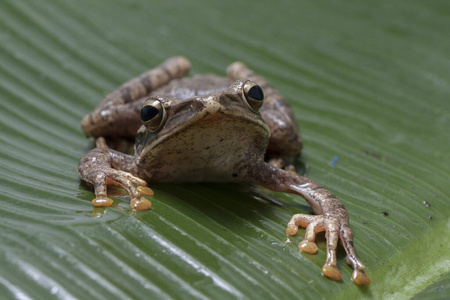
{"left": 0, "top": 0, "right": 450, "bottom": 299}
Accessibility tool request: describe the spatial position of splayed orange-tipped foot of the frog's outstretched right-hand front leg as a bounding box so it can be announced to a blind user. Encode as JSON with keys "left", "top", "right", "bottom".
{"left": 286, "top": 214, "right": 370, "bottom": 286}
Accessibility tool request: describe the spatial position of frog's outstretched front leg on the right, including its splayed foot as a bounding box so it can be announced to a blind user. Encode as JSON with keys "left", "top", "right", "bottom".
{"left": 254, "top": 164, "right": 370, "bottom": 285}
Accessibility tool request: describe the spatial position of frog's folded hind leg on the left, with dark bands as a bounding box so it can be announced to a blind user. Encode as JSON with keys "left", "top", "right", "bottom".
{"left": 81, "top": 56, "right": 191, "bottom": 137}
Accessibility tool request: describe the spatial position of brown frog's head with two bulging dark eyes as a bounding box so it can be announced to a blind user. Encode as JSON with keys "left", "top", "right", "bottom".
{"left": 136, "top": 80, "right": 270, "bottom": 175}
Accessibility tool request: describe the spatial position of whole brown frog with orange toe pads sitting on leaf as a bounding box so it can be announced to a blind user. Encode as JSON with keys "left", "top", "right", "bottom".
{"left": 78, "top": 56, "right": 371, "bottom": 286}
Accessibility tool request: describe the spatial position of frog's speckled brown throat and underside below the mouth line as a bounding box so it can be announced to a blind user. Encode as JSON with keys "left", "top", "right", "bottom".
{"left": 138, "top": 117, "right": 268, "bottom": 182}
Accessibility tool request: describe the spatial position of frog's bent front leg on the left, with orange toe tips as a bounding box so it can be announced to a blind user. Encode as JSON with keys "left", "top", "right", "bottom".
{"left": 78, "top": 138, "right": 153, "bottom": 210}
